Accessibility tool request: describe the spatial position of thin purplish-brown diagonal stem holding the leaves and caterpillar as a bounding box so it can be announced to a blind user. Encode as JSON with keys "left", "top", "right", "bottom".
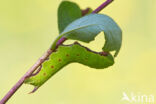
{"left": 0, "top": 0, "right": 113, "bottom": 104}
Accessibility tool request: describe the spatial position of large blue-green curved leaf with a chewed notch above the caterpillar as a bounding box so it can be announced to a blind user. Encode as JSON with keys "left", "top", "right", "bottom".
{"left": 60, "top": 14, "right": 122, "bottom": 56}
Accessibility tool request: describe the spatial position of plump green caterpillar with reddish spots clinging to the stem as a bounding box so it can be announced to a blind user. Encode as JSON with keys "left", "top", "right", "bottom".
{"left": 25, "top": 43, "right": 114, "bottom": 92}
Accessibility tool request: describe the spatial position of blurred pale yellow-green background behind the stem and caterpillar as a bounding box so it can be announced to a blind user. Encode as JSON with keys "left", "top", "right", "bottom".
{"left": 0, "top": 0, "right": 156, "bottom": 104}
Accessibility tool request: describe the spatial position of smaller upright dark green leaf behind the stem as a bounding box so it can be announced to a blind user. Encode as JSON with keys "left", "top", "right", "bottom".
{"left": 58, "top": 1, "right": 82, "bottom": 33}
